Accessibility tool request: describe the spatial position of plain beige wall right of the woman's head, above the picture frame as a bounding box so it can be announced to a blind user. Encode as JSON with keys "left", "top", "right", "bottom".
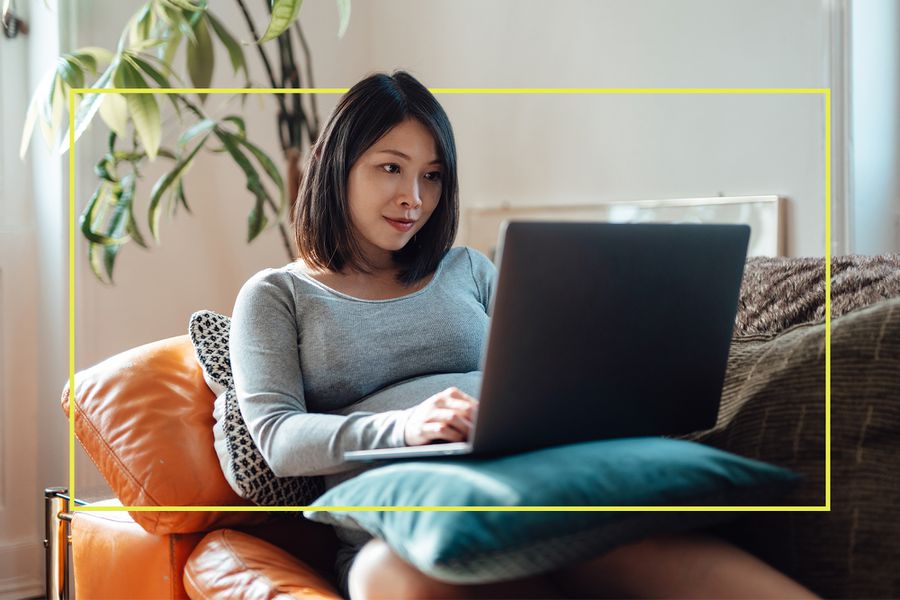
{"left": 356, "top": 0, "right": 829, "bottom": 255}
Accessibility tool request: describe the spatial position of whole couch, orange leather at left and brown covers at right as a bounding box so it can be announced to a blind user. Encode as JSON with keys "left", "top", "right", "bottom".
{"left": 48, "top": 255, "right": 900, "bottom": 598}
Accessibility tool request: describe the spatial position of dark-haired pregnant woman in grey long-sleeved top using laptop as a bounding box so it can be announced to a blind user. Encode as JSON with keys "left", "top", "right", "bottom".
{"left": 231, "top": 72, "right": 812, "bottom": 599}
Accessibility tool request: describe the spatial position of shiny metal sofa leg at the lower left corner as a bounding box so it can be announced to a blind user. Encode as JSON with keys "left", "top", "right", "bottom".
{"left": 44, "top": 487, "right": 72, "bottom": 600}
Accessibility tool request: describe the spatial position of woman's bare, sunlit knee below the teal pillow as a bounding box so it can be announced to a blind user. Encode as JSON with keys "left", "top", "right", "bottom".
{"left": 347, "top": 539, "right": 459, "bottom": 600}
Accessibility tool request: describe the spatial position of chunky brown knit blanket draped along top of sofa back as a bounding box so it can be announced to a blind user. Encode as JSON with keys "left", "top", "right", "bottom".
{"left": 734, "top": 253, "right": 900, "bottom": 337}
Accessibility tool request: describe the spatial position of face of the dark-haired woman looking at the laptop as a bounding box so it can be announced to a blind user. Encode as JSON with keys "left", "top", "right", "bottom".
{"left": 347, "top": 119, "right": 442, "bottom": 268}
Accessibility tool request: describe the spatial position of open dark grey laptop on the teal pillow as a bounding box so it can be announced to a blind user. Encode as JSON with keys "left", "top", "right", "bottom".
{"left": 344, "top": 221, "right": 750, "bottom": 461}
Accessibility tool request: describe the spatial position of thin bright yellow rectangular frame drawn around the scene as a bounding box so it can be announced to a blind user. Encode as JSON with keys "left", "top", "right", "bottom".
{"left": 69, "top": 88, "right": 831, "bottom": 512}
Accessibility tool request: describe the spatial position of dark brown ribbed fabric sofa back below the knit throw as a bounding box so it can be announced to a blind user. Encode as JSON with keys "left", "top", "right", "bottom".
{"left": 695, "top": 298, "right": 900, "bottom": 598}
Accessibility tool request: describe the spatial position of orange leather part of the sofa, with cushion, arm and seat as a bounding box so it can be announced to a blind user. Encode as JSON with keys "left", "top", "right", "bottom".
{"left": 57, "top": 335, "right": 341, "bottom": 599}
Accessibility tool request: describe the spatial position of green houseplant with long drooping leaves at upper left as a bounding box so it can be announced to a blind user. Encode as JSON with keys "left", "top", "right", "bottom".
{"left": 20, "top": 0, "right": 350, "bottom": 283}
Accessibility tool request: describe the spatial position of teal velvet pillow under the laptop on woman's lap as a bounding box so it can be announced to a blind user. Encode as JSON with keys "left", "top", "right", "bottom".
{"left": 305, "top": 437, "right": 798, "bottom": 583}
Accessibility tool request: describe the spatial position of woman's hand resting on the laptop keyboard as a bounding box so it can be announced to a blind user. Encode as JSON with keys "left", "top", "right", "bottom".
{"left": 403, "top": 387, "right": 478, "bottom": 446}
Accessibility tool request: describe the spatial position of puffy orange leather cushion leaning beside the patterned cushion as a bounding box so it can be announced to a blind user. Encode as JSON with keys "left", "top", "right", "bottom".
{"left": 62, "top": 335, "right": 265, "bottom": 535}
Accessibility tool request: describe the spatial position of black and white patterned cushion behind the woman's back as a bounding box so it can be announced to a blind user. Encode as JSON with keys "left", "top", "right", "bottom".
{"left": 188, "top": 310, "right": 325, "bottom": 506}
